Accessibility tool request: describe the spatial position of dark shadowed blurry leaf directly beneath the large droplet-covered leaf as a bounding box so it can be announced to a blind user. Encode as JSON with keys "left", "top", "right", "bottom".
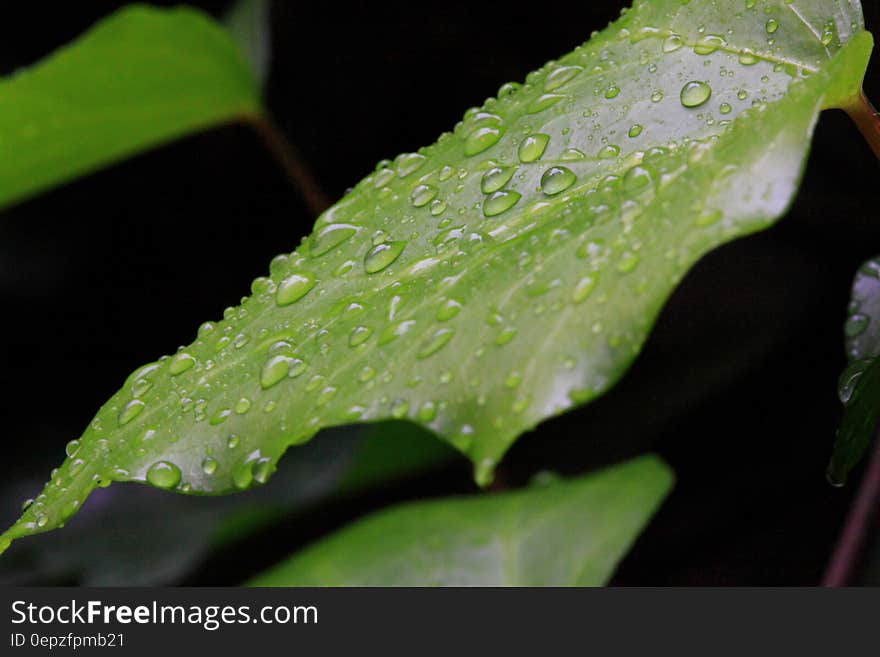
{"left": 0, "top": 423, "right": 456, "bottom": 586}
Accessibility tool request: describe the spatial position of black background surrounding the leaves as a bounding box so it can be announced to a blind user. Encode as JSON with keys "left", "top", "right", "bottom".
{"left": 0, "top": 0, "right": 880, "bottom": 585}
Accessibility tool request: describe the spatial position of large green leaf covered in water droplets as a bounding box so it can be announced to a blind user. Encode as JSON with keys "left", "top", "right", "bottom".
{"left": 2, "top": 0, "right": 872, "bottom": 552}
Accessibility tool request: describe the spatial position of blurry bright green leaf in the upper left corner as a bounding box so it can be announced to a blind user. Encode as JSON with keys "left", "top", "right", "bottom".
{"left": 0, "top": 6, "right": 261, "bottom": 207}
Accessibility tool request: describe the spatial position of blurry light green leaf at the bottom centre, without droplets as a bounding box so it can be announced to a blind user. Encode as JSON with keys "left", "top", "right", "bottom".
{"left": 249, "top": 457, "right": 673, "bottom": 586}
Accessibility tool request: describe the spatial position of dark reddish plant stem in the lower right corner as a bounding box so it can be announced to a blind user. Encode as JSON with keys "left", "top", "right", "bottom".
{"left": 822, "top": 436, "right": 880, "bottom": 587}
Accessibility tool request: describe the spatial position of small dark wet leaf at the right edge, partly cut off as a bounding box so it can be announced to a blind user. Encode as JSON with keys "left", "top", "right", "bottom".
{"left": 828, "top": 257, "right": 880, "bottom": 485}
